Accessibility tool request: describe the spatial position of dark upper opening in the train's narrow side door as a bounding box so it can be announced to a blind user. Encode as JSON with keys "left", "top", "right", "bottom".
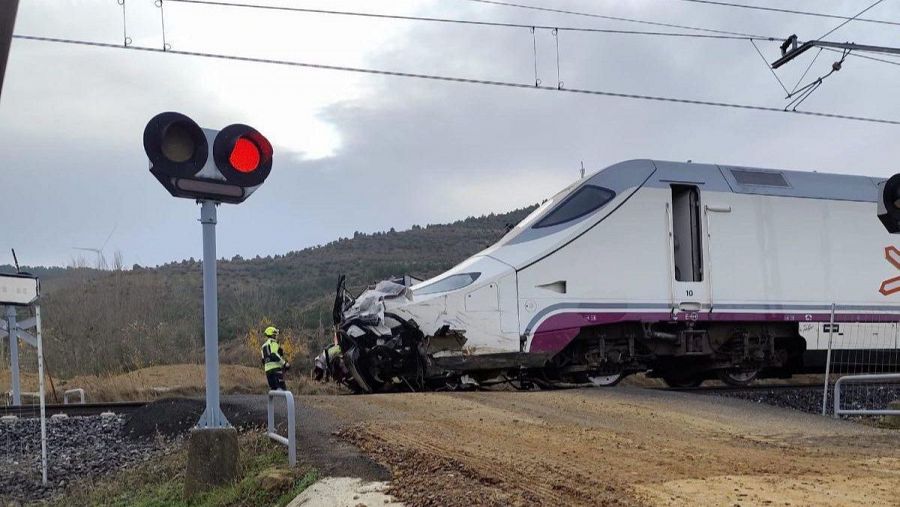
{"left": 672, "top": 185, "right": 703, "bottom": 282}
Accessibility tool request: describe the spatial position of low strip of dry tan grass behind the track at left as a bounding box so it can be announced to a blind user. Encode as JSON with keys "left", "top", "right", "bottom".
{"left": 0, "top": 364, "right": 341, "bottom": 403}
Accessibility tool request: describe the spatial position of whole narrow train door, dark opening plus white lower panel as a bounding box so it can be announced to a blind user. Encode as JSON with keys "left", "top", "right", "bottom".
{"left": 669, "top": 185, "right": 709, "bottom": 314}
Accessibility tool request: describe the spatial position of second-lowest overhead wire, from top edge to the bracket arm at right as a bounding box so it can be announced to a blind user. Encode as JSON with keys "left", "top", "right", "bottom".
{"left": 165, "top": 0, "right": 764, "bottom": 41}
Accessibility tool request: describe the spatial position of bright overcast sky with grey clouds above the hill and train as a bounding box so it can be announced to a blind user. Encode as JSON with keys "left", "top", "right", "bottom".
{"left": 0, "top": 0, "right": 900, "bottom": 266}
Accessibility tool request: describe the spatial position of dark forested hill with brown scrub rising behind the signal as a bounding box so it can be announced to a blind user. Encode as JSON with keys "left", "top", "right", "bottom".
{"left": 0, "top": 208, "right": 533, "bottom": 375}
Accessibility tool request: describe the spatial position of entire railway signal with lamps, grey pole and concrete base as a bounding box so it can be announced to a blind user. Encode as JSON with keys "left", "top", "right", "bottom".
{"left": 144, "top": 112, "right": 272, "bottom": 497}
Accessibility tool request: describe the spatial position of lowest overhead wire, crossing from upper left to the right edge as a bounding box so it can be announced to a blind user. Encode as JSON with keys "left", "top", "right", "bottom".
{"left": 13, "top": 35, "right": 900, "bottom": 125}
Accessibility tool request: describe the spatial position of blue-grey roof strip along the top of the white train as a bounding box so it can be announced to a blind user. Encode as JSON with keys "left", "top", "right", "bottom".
{"left": 636, "top": 160, "right": 883, "bottom": 202}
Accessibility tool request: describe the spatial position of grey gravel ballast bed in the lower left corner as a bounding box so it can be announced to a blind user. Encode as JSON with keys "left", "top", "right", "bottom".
{"left": 0, "top": 416, "right": 165, "bottom": 502}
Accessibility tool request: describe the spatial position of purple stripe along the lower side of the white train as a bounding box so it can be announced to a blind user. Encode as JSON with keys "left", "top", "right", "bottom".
{"left": 528, "top": 312, "right": 900, "bottom": 353}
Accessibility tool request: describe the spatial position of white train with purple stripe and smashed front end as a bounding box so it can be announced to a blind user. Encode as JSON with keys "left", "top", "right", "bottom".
{"left": 320, "top": 160, "right": 900, "bottom": 392}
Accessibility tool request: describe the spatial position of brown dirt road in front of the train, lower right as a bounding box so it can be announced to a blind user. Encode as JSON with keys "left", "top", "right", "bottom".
{"left": 290, "top": 387, "right": 900, "bottom": 506}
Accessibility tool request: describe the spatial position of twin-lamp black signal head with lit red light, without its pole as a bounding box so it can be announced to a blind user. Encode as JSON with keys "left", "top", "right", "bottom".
{"left": 144, "top": 112, "right": 273, "bottom": 204}
